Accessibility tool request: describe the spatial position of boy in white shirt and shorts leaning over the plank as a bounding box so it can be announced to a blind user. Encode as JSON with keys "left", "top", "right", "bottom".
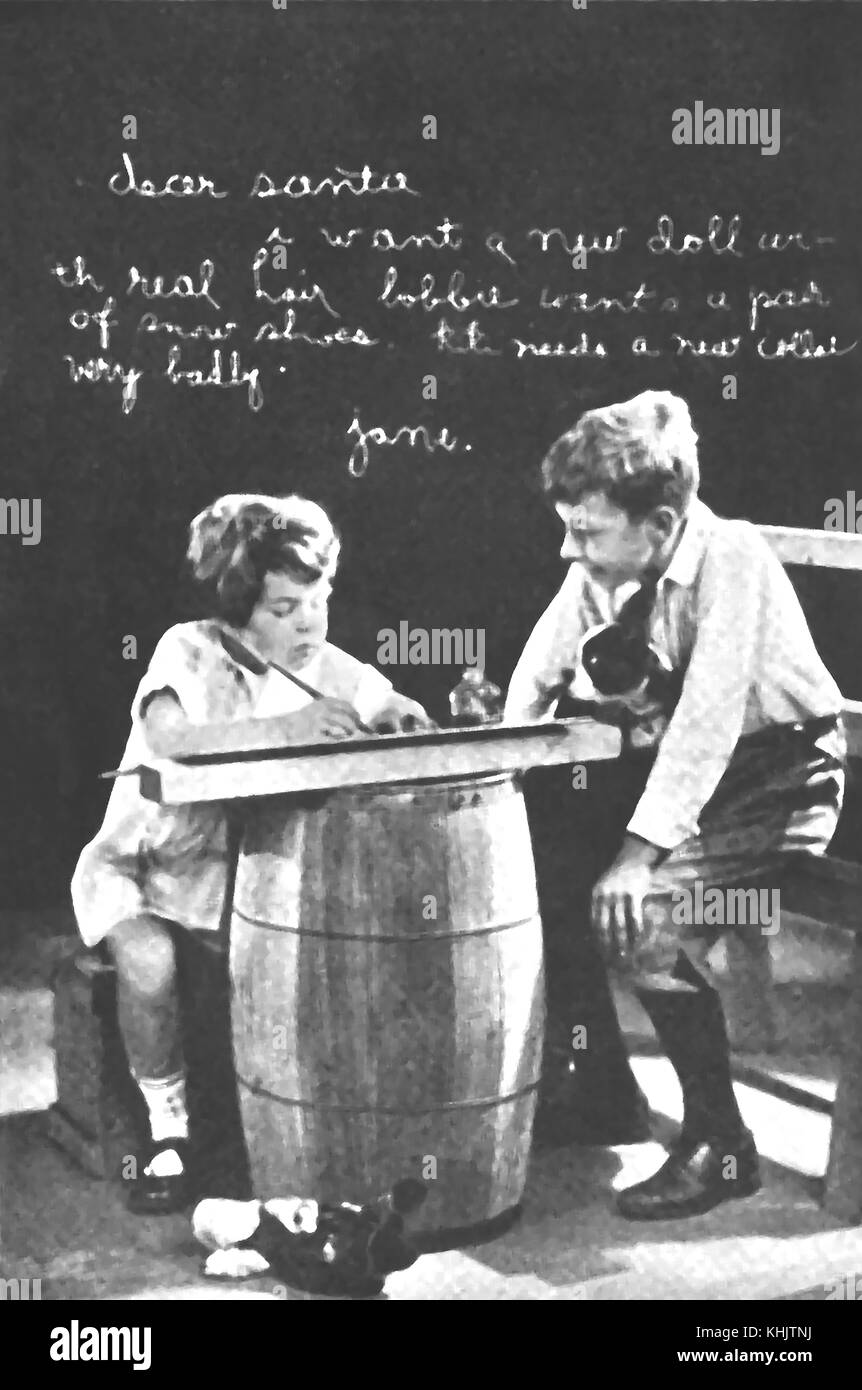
{"left": 506, "top": 391, "right": 845, "bottom": 1220}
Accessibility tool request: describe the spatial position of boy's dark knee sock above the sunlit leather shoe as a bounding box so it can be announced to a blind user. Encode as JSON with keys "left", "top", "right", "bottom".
{"left": 637, "top": 952, "right": 745, "bottom": 1140}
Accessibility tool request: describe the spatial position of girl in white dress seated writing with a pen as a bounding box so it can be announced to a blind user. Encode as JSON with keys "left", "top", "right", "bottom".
{"left": 72, "top": 495, "right": 427, "bottom": 1212}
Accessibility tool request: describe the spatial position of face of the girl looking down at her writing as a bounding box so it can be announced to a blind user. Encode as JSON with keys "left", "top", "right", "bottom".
{"left": 243, "top": 573, "right": 332, "bottom": 670}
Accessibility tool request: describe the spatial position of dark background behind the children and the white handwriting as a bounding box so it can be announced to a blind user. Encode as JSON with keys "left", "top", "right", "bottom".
{"left": 0, "top": 0, "right": 862, "bottom": 904}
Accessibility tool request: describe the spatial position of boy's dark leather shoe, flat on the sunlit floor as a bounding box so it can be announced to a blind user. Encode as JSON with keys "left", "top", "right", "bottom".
{"left": 617, "top": 1130, "right": 761, "bottom": 1220}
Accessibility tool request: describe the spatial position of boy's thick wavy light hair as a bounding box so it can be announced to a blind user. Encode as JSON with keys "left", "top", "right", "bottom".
{"left": 542, "top": 391, "right": 699, "bottom": 521}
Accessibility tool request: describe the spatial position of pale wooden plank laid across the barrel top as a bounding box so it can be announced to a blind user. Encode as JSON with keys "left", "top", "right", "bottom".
{"left": 138, "top": 719, "right": 621, "bottom": 805}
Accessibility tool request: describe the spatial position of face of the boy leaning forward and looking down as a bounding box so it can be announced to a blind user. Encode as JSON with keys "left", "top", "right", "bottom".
{"left": 556, "top": 492, "right": 680, "bottom": 589}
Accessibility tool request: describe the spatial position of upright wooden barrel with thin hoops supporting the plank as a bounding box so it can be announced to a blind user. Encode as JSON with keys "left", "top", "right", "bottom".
{"left": 231, "top": 774, "right": 545, "bottom": 1232}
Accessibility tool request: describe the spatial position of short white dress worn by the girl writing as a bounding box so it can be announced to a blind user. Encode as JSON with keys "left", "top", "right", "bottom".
{"left": 72, "top": 621, "right": 392, "bottom": 947}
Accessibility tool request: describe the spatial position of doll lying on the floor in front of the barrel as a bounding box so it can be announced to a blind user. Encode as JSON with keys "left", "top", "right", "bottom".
{"left": 192, "top": 1179, "right": 427, "bottom": 1298}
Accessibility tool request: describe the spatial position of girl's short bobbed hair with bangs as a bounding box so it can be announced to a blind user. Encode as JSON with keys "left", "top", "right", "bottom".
{"left": 186, "top": 493, "right": 341, "bottom": 627}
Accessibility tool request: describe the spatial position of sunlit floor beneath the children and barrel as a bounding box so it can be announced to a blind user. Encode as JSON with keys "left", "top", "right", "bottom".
{"left": 0, "top": 906, "right": 862, "bottom": 1301}
